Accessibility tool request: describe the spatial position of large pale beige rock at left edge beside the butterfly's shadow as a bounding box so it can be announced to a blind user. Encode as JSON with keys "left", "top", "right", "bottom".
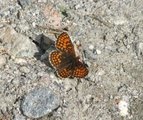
{"left": 0, "top": 27, "right": 37, "bottom": 57}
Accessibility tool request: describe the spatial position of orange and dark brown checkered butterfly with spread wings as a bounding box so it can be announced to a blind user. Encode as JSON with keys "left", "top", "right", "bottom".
{"left": 49, "top": 32, "right": 89, "bottom": 78}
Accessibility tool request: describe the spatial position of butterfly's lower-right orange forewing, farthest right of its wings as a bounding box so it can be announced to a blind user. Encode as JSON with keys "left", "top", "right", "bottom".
{"left": 72, "top": 61, "right": 89, "bottom": 78}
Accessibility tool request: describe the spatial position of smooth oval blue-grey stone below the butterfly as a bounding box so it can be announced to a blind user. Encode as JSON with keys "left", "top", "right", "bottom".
{"left": 21, "top": 87, "right": 60, "bottom": 118}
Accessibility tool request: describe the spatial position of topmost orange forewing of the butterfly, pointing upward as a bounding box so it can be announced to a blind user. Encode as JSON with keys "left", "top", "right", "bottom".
{"left": 56, "top": 32, "right": 75, "bottom": 55}
